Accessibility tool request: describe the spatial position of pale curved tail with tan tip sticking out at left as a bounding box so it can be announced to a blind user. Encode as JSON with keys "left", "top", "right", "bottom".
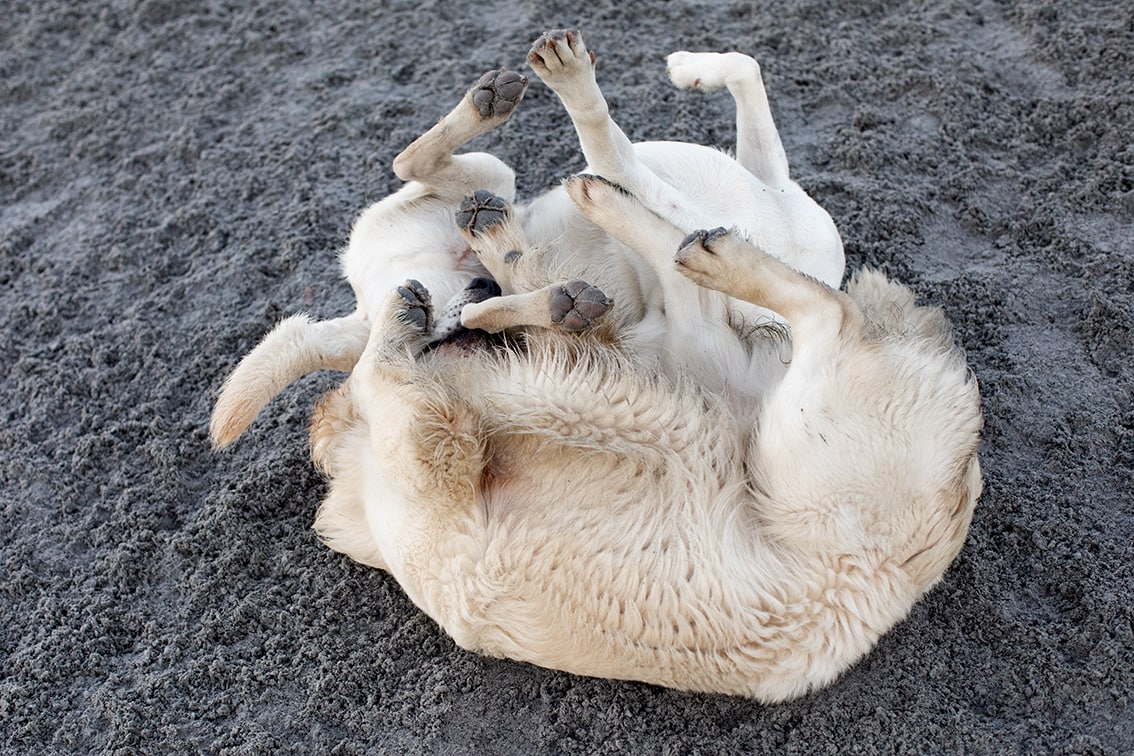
{"left": 209, "top": 315, "right": 370, "bottom": 449}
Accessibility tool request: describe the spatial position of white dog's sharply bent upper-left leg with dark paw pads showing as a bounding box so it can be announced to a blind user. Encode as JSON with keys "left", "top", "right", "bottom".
{"left": 393, "top": 69, "right": 527, "bottom": 203}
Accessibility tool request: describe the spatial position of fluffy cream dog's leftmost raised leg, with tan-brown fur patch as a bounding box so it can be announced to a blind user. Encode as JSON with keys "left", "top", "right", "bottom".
{"left": 349, "top": 281, "right": 486, "bottom": 607}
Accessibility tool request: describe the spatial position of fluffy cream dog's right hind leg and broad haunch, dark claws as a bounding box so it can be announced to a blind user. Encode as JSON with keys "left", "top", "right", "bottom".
{"left": 676, "top": 229, "right": 981, "bottom": 575}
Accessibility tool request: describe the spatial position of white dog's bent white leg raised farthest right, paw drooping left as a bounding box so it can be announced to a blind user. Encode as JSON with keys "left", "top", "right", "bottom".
{"left": 666, "top": 51, "right": 790, "bottom": 186}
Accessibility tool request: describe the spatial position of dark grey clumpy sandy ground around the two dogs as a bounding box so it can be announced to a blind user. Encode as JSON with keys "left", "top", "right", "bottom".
{"left": 0, "top": 0, "right": 1134, "bottom": 754}
